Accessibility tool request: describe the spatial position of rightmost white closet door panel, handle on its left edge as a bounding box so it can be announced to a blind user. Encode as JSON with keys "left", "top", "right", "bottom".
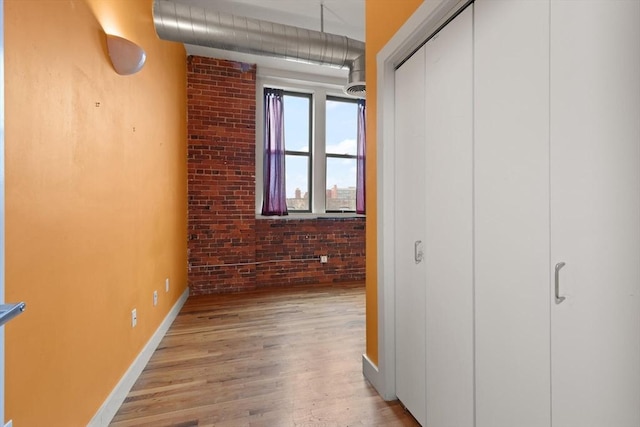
{"left": 551, "top": 0, "right": 640, "bottom": 427}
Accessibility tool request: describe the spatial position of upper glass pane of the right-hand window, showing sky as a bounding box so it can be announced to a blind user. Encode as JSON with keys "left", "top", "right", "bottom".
{"left": 325, "top": 99, "right": 358, "bottom": 155}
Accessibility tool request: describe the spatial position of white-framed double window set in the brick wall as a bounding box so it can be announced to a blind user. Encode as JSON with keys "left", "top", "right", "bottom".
{"left": 256, "top": 78, "right": 359, "bottom": 216}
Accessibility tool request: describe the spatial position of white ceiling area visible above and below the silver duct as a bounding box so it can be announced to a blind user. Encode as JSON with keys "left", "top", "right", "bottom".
{"left": 173, "top": 0, "right": 365, "bottom": 78}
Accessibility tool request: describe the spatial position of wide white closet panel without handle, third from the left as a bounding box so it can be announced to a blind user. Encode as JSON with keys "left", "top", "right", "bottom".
{"left": 474, "top": 0, "right": 552, "bottom": 427}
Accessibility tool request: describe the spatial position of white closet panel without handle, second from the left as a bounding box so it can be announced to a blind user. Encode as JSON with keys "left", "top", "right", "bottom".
{"left": 424, "top": 6, "right": 474, "bottom": 427}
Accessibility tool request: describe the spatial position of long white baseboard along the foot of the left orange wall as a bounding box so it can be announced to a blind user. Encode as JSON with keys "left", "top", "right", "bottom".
{"left": 87, "top": 288, "right": 189, "bottom": 427}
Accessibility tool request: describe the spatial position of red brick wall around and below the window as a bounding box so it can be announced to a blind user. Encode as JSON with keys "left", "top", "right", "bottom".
{"left": 187, "top": 56, "right": 365, "bottom": 295}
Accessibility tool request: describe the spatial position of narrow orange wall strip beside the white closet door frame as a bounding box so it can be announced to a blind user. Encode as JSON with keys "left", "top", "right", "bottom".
{"left": 365, "top": 0, "right": 428, "bottom": 365}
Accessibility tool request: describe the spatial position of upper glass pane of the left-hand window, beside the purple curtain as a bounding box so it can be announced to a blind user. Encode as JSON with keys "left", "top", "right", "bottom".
{"left": 284, "top": 94, "right": 311, "bottom": 153}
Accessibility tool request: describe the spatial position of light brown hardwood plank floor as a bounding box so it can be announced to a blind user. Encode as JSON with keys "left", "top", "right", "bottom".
{"left": 111, "top": 284, "right": 418, "bottom": 427}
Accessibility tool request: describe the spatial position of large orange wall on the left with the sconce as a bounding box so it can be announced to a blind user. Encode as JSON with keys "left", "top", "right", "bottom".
{"left": 4, "top": 0, "right": 187, "bottom": 426}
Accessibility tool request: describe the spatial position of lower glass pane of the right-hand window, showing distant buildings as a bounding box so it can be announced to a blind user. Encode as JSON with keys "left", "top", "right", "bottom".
{"left": 326, "top": 157, "right": 356, "bottom": 211}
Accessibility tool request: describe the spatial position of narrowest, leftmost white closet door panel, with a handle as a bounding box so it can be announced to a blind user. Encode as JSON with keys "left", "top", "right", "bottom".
{"left": 394, "top": 44, "right": 426, "bottom": 425}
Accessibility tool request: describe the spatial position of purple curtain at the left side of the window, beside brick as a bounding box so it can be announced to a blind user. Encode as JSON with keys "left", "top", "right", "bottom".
{"left": 262, "top": 88, "right": 288, "bottom": 215}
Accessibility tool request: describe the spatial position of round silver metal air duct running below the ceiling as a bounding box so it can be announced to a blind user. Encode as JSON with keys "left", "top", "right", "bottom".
{"left": 153, "top": 0, "right": 365, "bottom": 97}
